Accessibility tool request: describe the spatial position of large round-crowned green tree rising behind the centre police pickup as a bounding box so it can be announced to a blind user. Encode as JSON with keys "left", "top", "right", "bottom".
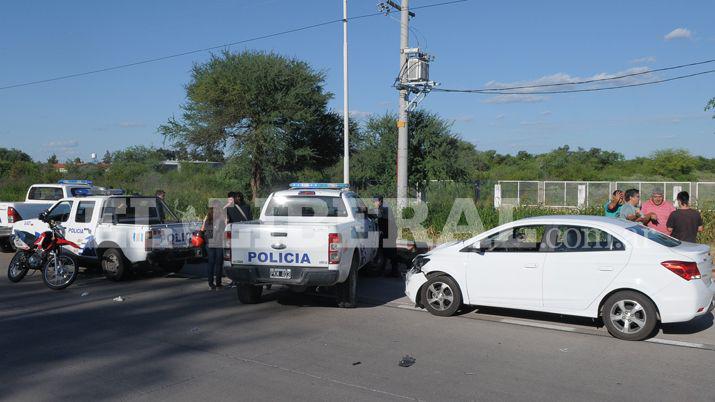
{"left": 159, "top": 51, "right": 341, "bottom": 199}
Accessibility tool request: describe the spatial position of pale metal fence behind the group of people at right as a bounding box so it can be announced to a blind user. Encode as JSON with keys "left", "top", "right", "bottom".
{"left": 494, "top": 180, "right": 715, "bottom": 208}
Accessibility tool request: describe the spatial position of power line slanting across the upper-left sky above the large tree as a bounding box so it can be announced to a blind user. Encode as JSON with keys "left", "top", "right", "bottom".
{"left": 0, "top": 0, "right": 469, "bottom": 91}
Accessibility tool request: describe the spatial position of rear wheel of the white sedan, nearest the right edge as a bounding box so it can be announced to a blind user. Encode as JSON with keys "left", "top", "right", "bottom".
{"left": 601, "top": 291, "right": 658, "bottom": 341}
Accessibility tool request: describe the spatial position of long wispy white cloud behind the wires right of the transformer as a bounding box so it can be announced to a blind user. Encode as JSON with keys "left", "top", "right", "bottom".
{"left": 484, "top": 67, "right": 654, "bottom": 104}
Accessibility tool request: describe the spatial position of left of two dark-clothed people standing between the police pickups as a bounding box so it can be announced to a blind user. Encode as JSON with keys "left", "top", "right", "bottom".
{"left": 201, "top": 200, "right": 226, "bottom": 290}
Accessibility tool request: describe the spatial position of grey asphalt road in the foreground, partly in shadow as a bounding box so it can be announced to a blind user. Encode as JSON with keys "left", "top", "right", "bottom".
{"left": 0, "top": 254, "right": 715, "bottom": 401}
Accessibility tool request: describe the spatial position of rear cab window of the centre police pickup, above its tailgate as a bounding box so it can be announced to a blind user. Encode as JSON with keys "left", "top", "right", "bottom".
{"left": 266, "top": 195, "right": 348, "bottom": 218}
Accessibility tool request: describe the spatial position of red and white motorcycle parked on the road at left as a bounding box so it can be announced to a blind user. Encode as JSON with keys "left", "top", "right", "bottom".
{"left": 7, "top": 212, "right": 79, "bottom": 290}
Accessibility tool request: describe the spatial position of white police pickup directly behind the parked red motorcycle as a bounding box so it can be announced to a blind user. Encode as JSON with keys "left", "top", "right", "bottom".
{"left": 14, "top": 195, "right": 200, "bottom": 280}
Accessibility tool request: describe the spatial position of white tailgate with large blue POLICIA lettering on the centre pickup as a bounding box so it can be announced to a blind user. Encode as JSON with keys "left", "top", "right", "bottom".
{"left": 231, "top": 222, "right": 336, "bottom": 268}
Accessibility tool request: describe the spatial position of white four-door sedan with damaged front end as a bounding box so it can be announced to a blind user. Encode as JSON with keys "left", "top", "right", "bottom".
{"left": 405, "top": 215, "right": 715, "bottom": 340}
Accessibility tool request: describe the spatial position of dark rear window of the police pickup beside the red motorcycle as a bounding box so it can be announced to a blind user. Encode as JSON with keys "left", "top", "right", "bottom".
{"left": 102, "top": 197, "right": 179, "bottom": 225}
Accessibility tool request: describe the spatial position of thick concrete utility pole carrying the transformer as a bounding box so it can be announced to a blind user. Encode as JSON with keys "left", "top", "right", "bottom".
{"left": 397, "top": 0, "right": 410, "bottom": 209}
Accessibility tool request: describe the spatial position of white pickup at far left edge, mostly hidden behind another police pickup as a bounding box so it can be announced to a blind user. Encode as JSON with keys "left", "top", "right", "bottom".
{"left": 0, "top": 180, "right": 92, "bottom": 252}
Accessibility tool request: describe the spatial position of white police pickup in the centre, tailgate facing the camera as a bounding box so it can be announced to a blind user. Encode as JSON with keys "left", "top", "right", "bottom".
{"left": 224, "top": 183, "right": 379, "bottom": 307}
